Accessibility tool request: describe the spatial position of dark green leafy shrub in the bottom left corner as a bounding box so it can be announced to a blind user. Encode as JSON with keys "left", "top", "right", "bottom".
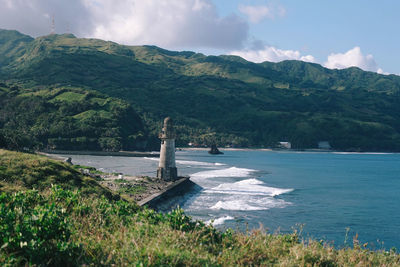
{"left": 0, "top": 188, "right": 80, "bottom": 265}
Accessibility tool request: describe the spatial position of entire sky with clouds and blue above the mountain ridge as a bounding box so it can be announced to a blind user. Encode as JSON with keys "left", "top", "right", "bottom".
{"left": 0, "top": 0, "right": 400, "bottom": 75}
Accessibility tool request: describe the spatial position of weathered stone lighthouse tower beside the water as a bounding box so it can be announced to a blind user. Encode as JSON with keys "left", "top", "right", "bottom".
{"left": 157, "top": 117, "right": 178, "bottom": 181}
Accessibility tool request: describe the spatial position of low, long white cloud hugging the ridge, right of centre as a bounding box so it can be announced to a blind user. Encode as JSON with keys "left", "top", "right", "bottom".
{"left": 230, "top": 46, "right": 315, "bottom": 63}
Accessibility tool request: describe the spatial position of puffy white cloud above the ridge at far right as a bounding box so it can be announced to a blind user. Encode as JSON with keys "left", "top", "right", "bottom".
{"left": 324, "top": 46, "right": 385, "bottom": 74}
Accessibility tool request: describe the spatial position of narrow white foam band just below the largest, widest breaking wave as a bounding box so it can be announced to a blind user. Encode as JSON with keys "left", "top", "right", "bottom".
{"left": 211, "top": 197, "right": 291, "bottom": 211}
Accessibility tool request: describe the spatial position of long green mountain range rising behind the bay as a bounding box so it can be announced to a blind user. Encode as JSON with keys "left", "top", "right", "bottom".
{"left": 0, "top": 30, "right": 400, "bottom": 151}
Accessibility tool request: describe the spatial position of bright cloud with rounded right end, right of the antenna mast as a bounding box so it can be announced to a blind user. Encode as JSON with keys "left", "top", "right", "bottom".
{"left": 85, "top": 0, "right": 248, "bottom": 49}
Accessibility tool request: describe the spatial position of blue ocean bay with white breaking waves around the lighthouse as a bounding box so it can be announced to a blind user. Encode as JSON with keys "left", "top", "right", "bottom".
{"left": 59, "top": 150, "right": 400, "bottom": 249}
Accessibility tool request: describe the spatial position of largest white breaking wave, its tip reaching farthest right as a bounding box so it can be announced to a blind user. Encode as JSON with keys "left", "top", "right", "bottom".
{"left": 206, "top": 179, "right": 293, "bottom": 197}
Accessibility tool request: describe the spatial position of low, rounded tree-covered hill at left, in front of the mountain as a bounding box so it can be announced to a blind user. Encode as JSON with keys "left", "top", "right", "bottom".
{"left": 0, "top": 83, "right": 146, "bottom": 151}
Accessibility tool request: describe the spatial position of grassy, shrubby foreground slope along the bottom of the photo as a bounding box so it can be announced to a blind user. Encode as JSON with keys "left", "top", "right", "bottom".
{"left": 0, "top": 151, "right": 400, "bottom": 266}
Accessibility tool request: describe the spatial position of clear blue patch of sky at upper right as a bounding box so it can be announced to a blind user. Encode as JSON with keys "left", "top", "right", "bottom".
{"left": 215, "top": 0, "right": 400, "bottom": 74}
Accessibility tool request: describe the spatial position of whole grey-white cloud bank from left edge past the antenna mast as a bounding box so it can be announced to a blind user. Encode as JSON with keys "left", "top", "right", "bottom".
{"left": 0, "top": 0, "right": 249, "bottom": 49}
